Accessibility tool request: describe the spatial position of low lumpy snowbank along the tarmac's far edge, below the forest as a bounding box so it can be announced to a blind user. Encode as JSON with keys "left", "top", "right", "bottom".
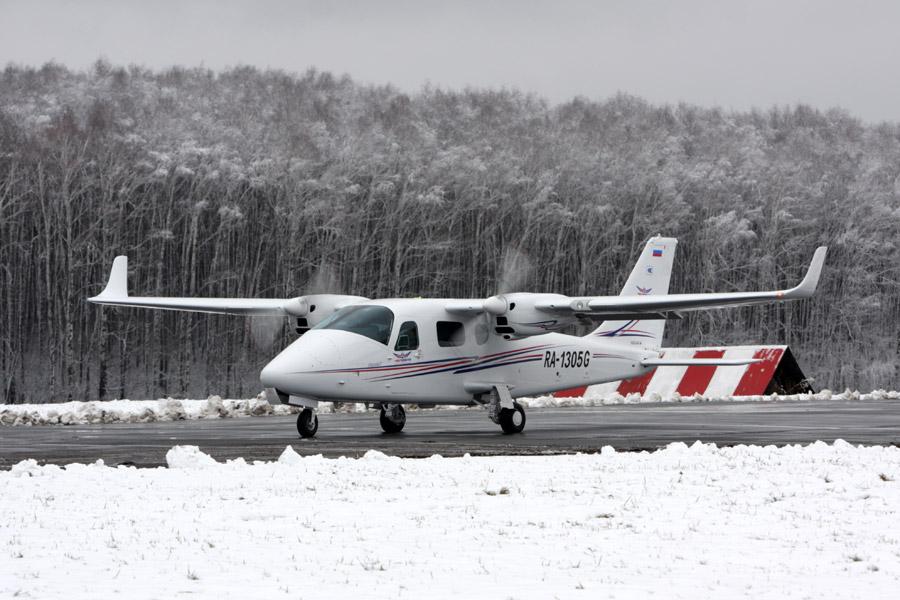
{"left": 0, "top": 390, "right": 900, "bottom": 426}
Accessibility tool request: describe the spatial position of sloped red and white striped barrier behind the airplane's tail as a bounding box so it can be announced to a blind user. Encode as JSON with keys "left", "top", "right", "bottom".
{"left": 553, "top": 346, "right": 787, "bottom": 398}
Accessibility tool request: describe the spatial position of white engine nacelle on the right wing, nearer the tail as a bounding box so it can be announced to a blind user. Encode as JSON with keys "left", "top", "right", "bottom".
{"left": 484, "top": 293, "right": 577, "bottom": 338}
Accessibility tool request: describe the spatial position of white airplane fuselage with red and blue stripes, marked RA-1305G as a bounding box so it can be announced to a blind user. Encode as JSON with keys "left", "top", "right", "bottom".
{"left": 260, "top": 299, "right": 656, "bottom": 404}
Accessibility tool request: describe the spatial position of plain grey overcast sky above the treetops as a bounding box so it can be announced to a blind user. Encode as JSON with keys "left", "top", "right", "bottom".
{"left": 0, "top": 0, "right": 900, "bottom": 121}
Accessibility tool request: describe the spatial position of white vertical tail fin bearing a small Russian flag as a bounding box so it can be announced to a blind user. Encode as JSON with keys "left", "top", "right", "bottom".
{"left": 589, "top": 236, "right": 678, "bottom": 349}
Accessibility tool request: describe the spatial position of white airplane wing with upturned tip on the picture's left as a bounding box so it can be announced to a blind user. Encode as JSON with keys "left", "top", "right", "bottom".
{"left": 88, "top": 256, "right": 366, "bottom": 317}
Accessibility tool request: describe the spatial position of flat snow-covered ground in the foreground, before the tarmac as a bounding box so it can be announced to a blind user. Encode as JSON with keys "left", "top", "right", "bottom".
{"left": 0, "top": 441, "right": 900, "bottom": 600}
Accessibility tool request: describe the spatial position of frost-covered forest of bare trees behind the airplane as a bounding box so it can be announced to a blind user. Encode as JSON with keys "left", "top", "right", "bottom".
{"left": 0, "top": 61, "right": 900, "bottom": 402}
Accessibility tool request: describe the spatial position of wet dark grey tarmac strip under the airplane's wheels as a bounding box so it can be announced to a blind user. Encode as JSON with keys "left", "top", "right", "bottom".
{"left": 0, "top": 399, "right": 900, "bottom": 468}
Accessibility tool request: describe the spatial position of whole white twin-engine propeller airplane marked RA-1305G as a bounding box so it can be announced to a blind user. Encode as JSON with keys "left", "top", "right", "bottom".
{"left": 90, "top": 236, "right": 826, "bottom": 437}
